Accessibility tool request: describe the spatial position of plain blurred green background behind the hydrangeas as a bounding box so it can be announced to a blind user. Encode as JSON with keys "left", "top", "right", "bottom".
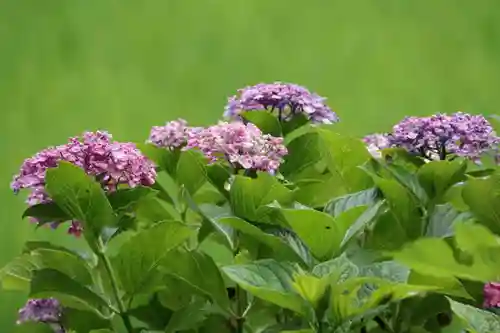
{"left": 0, "top": 0, "right": 500, "bottom": 332}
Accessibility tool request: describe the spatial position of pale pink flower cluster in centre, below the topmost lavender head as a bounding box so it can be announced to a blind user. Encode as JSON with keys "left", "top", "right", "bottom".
{"left": 185, "top": 122, "right": 287, "bottom": 173}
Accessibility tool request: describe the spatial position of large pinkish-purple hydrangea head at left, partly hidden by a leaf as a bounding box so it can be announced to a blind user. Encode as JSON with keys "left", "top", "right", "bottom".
{"left": 11, "top": 131, "right": 156, "bottom": 236}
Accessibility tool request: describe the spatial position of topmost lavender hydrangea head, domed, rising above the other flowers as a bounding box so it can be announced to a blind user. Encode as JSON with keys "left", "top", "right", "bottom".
{"left": 224, "top": 82, "right": 339, "bottom": 124}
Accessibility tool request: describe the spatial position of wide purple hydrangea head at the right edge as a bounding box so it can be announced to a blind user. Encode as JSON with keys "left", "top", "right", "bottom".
{"left": 389, "top": 112, "right": 499, "bottom": 159}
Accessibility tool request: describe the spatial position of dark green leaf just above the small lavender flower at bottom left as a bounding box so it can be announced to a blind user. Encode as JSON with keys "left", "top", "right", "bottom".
{"left": 30, "top": 268, "right": 108, "bottom": 314}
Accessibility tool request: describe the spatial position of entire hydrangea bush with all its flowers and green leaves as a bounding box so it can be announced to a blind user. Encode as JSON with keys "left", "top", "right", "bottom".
{"left": 0, "top": 82, "right": 500, "bottom": 333}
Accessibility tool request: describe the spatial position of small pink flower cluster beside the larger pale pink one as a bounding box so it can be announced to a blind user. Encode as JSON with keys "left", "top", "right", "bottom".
{"left": 147, "top": 119, "right": 197, "bottom": 149}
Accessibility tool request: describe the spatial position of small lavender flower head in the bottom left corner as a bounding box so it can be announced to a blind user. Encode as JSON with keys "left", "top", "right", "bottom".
{"left": 17, "top": 298, "right": 65, "bottom": 333}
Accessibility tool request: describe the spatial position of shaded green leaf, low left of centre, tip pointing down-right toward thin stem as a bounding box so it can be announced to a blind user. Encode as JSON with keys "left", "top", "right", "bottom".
{"left": 161, "top": 251, "right": 229, "bottom": 310}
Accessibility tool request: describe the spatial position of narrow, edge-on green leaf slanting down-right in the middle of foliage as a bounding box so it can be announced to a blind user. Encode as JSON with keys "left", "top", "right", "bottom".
{"left": 218, "top": 217, "right": 309, "bottom": 264}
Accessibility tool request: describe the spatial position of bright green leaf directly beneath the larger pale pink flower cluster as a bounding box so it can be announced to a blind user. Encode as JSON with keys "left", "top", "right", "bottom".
{"left": 230, "top": 172, "right": 293, "bottom": 222}
